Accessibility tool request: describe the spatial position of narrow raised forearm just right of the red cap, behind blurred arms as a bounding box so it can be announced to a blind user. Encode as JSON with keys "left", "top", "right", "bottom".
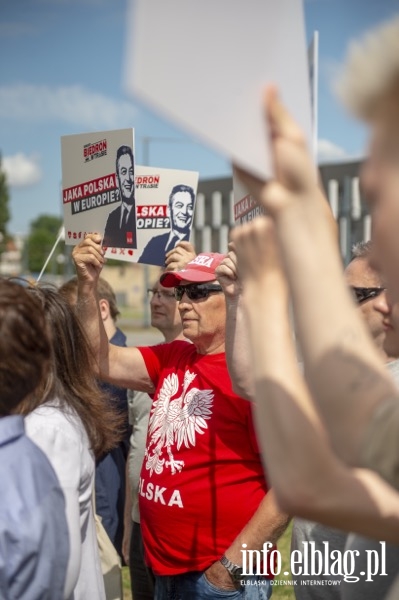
{"left": 216, "top": 243, "right": 255, "bottom": 400}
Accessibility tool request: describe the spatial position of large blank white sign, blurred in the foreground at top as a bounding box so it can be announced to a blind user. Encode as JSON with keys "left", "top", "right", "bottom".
{"left": 125, "top": 0, "right": 312, "bottom": 179}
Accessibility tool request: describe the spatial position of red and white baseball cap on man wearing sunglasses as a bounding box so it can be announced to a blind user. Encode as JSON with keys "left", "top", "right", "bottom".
{"left": 160, "top": 252, "right": 225, "bottom": 287}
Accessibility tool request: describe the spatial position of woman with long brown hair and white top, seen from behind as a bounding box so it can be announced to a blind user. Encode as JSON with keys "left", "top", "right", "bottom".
{"left": 19, "top": 286, "right": 122, "bottom": 600}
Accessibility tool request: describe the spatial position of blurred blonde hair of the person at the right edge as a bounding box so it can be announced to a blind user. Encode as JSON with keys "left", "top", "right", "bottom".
{"left": 336, "top": 16, "right": 399, "bottom": 121}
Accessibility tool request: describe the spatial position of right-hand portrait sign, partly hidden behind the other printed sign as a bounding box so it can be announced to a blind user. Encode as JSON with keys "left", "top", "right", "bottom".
{"left": 104, "top": 165, "right": 198, "bottom": 266}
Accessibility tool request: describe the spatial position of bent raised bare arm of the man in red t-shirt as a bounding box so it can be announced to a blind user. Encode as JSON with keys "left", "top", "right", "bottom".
{"left": 72, "top": 234, "right": 154, "bottom": 393}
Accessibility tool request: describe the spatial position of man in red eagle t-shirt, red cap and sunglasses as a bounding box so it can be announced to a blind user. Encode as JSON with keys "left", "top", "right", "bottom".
{"left": 73, "top": 234, "right": 288, "bottom": 600}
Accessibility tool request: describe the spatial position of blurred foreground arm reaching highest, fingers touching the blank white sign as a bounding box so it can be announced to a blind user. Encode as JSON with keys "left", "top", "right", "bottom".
{"left": 236, "top": 86, "right": 396, "bottom": 466}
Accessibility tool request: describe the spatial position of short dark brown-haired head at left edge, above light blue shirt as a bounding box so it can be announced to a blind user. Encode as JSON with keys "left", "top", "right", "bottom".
{"left": 0, "top": 280, "right": 51, "bottom": 416}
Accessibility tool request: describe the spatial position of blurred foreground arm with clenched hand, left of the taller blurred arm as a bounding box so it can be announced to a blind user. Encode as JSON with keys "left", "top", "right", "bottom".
{"left": 233, "top": 218, "right": 399, "bottom": 542}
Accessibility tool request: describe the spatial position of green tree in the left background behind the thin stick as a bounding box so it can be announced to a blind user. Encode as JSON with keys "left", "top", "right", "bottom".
{"left": 26, "top": 215, "right": 65, "bottom": 274}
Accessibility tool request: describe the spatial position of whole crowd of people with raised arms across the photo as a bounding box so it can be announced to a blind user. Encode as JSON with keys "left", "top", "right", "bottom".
{"left": 0, "top": 12, "right": 399, "bottom": 600}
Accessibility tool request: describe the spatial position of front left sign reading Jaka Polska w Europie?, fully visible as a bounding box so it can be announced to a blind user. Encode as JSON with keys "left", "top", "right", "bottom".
{"left": 61, "top": 129, "right": 137, "bottom": 249}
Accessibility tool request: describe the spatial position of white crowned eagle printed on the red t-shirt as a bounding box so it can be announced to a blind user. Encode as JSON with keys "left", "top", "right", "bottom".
{"left": 145, "top": 371, "right": 214, "bottom": 475}
